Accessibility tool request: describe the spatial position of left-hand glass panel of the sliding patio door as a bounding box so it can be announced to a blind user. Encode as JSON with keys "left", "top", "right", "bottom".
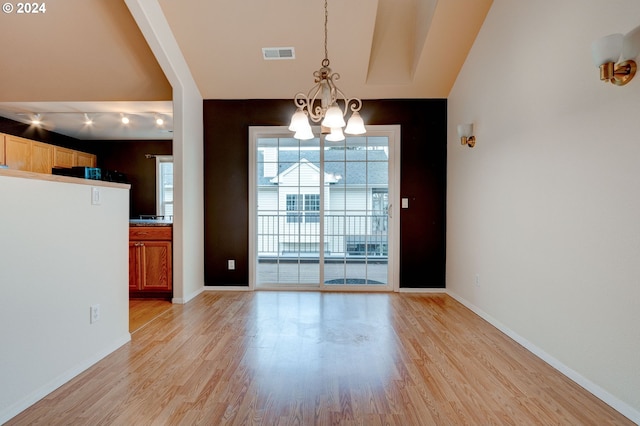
{"left": 256, "top": 137, "right": 322, "bottom": 287}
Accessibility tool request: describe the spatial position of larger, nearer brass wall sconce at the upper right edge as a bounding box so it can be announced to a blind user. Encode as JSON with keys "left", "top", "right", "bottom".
{"left": 591, "top": 27, "right": 640, "bottom": 86}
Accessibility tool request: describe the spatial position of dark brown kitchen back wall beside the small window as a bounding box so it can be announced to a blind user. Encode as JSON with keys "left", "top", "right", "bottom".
{"left": 87, "top": 140, "right": 173, "bottom": 218}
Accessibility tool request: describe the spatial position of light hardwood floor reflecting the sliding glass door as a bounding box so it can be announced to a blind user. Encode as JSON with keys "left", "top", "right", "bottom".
{"left": 8, "top": 292, "right": 633, "bottom": 426}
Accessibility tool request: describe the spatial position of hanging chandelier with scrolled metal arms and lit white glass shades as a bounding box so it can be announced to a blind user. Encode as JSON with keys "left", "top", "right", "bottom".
{"left": 289, "top": 0, "right": 366, "bottom": 141}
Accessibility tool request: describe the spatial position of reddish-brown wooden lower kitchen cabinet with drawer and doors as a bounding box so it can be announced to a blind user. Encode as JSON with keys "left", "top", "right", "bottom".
{"left": 129, "top": 226, "right": 173, "bottom": 298}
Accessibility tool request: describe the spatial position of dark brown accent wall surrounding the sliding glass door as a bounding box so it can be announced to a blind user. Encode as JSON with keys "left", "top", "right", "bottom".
{"left": 204, "top": 99, "right": 447, "bottom": 288}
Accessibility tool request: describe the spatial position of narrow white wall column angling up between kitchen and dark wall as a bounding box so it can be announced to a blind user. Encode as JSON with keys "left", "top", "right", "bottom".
{"left": 125, "top": 0, "right": 204, "bottom": 303}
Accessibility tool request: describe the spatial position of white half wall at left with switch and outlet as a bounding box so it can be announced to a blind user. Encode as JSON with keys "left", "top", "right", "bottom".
{"left": 0, "top": 174, "right": 131, "bottom": 423}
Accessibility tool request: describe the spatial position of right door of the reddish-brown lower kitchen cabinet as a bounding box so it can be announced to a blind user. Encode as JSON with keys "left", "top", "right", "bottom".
{"left": 140, "top": 241, "right": 172, "bottom": 291}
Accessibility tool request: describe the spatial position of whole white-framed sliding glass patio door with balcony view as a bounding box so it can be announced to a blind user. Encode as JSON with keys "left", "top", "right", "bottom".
{"left": 249, "top": 126, "right": 400, "bottom": 291}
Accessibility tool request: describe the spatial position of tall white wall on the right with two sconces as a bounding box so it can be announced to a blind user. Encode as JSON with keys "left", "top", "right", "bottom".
{"left": 447, "top": 0, "right": 640, "bottom": 422}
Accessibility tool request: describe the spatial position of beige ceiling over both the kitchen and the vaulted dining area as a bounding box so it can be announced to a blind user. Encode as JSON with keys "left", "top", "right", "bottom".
{"left": 0, "top": 0, "right": 492, "bottom": 140}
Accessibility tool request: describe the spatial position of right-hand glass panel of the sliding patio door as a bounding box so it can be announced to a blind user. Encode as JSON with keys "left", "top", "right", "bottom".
{"left": 323, "top": 136, "right": 389, "bottom": 287}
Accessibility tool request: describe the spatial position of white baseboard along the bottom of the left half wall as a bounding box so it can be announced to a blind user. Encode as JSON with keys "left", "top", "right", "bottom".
{"left": 0, "top": 333, "right": 131, "bottom": 424}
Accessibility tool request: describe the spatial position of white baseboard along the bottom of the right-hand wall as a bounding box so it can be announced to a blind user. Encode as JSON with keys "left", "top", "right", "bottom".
{"left": 447, "top": 290, "right": 640, "bottom": 424}
